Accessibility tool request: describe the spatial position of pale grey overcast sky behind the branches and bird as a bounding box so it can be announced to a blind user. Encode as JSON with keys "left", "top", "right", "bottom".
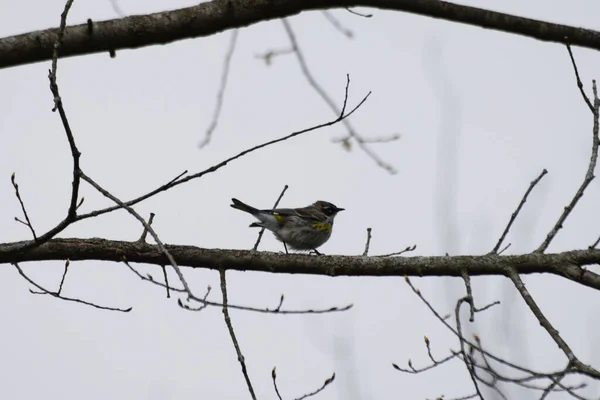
{"left": 0, "top": 0, "right": 600, "bottom": 400}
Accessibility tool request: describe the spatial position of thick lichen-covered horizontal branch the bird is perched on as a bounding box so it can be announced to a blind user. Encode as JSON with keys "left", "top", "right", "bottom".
{"left": 0, "top": 238, "right": 600, "bottom": 289}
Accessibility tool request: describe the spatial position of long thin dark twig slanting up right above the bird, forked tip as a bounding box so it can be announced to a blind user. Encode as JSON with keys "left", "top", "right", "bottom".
{"left": 77, "top": 75, "right": 371, "bottom": 220}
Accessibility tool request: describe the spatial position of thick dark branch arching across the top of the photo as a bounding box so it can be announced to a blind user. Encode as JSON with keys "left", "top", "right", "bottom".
{"left": 0, "top": 0, "right": 600, "bottom": 68}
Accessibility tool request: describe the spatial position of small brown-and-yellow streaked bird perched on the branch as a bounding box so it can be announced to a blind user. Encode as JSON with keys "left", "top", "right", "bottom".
{"left": 231, "top": 198, "right": 344, "bottom": 255}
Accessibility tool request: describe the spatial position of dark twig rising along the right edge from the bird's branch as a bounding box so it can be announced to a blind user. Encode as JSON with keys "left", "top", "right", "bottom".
{"left": 535, "top": 80, "right": 600, "bottom": 253}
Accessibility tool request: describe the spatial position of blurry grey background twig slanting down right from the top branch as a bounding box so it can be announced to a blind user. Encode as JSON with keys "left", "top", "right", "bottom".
{"left": 281, "top": 18, "right": 396, "bottom": 174}
